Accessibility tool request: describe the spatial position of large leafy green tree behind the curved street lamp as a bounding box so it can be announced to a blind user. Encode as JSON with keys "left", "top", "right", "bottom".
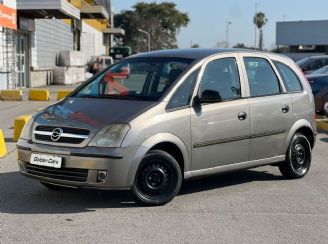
{"left": 114, "top": 2, "right": 189, "bottom": 52}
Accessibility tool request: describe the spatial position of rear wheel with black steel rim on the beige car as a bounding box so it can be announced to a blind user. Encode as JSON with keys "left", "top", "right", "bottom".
{"left": 279, "top": 133, "right": 312, "bottom": 179}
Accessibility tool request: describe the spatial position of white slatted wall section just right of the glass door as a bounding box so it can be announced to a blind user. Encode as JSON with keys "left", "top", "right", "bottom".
{"left": 31, "top": 19, "right": 73, "bottom": 68}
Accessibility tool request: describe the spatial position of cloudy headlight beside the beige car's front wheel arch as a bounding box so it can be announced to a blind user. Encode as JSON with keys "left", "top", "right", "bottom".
{"left": 89, "top": 124, "right": 130, "bottom": 147}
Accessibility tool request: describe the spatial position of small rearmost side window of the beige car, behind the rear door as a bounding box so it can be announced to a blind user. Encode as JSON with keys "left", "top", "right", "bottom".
{"left": 273, "top": 61, "right": 303, "bottom": 92}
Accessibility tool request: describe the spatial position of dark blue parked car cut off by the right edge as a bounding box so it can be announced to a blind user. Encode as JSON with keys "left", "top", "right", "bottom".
{"left": 307, "top": 74, "right": 328, "bottom": 113}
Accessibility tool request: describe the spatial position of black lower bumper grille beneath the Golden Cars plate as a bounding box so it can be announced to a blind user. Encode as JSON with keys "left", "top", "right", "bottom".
{"left": 25, "top": 163, "right": 88, "bottom": 182}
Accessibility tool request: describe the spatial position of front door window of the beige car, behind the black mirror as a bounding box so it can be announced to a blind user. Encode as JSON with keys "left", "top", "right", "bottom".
{"left": 199, "top": 58, "right": 241, "bottom": 102}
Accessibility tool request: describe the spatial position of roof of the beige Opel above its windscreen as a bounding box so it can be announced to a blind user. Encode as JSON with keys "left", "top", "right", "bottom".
{"left": 128, "top": 48, "right": 259, "bottom": 60}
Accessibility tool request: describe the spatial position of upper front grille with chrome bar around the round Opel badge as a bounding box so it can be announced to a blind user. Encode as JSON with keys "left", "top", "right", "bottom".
{"left": 33, "top": 125, "right": 90, "bottom": 144}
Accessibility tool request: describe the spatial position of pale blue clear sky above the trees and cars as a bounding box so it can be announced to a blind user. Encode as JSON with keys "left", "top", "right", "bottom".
{"left": 112, "top": 0, "right": 328, "bottom": 49}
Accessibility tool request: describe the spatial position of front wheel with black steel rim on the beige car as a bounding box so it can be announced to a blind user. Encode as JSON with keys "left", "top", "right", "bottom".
{"left": 132, "top": 150, "right": 182, "bottom": 206}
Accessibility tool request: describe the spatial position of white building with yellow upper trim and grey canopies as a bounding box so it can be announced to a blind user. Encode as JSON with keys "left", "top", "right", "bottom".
{"left": 0, "top": 0, "right": 124, "bottom": 90}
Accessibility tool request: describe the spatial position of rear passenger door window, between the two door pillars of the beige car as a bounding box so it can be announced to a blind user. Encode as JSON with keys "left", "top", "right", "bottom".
{"left": 244, "top": 58, "right": 281, "bottom": 97}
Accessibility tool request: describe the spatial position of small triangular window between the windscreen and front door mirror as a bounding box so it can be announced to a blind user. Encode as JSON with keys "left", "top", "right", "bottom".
{"left": 167, "top": 69, "right": 199, "bottom": 109}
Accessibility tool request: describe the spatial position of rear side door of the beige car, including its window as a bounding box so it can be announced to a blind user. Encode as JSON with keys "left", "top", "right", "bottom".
{"left": 242, "top": 54, "right": 292, "bottom": 160}
